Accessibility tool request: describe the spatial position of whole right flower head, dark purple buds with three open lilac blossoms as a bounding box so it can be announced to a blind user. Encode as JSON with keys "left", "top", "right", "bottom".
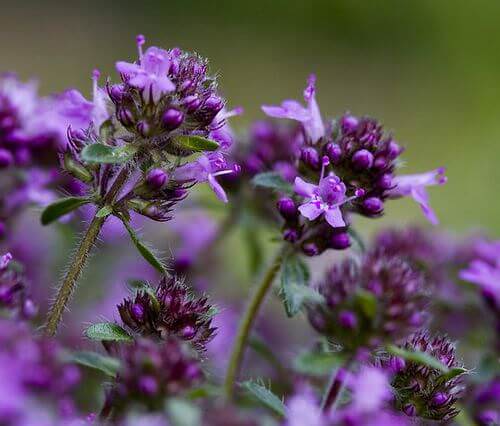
{"left": 263, "top": 76, "right": 446, "bottom": 256}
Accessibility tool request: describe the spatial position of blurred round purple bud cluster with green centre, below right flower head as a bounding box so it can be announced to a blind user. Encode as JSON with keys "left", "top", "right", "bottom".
{"left": 308, "top": 250, "right": 428, "bottom": 352}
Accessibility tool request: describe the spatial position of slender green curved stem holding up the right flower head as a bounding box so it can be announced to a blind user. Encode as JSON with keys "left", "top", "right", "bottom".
{"left": 224, "top": 245, "right": 287, "bottom": 400}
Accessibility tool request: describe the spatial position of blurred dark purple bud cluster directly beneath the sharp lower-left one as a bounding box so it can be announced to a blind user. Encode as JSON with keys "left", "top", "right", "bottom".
{"left": 102, "top": 337, "right": 203, "bottom": 418}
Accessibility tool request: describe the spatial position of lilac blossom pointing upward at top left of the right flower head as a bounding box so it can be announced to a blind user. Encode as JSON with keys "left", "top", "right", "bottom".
{"left": 262, "top": 74, "right": 325, "bottom": 143}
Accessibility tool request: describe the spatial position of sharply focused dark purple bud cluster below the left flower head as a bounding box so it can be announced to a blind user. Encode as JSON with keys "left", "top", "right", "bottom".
{"left": 118, "top": 277, "right": 216, "bottom": 352}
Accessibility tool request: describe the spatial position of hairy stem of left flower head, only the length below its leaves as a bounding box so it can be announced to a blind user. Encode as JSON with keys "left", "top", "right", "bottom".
{"left": 45, "top": 217, "right": 106, "bottom": 336}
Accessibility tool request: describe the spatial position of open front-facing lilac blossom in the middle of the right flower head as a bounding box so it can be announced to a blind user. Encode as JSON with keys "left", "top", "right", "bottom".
{"left": 294, "top": 157, "right": 362, "bottom": 228}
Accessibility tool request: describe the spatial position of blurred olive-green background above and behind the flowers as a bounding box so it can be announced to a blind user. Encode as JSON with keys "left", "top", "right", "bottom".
{"left": 0, "top": 0, "right": 500, "bottom": 236}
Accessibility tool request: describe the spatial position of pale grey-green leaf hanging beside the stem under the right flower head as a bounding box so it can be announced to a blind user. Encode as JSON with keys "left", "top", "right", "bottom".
{"left": 280, "top": 254, "right": 312, "bottom": 317}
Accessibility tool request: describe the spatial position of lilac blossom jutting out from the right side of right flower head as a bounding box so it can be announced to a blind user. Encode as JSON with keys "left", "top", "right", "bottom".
{"left": 388, "top": 167, "right": 447, "bottom": 225}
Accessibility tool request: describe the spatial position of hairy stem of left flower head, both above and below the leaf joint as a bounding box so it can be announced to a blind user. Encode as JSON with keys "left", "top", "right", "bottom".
{"left": 45, "top": 165, "right": 129, "bottom": 336}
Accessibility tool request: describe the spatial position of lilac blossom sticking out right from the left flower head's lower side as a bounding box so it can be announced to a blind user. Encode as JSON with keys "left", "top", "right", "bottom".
{"left": 174, "top": 152, "right": 238, "bottom": 203}
